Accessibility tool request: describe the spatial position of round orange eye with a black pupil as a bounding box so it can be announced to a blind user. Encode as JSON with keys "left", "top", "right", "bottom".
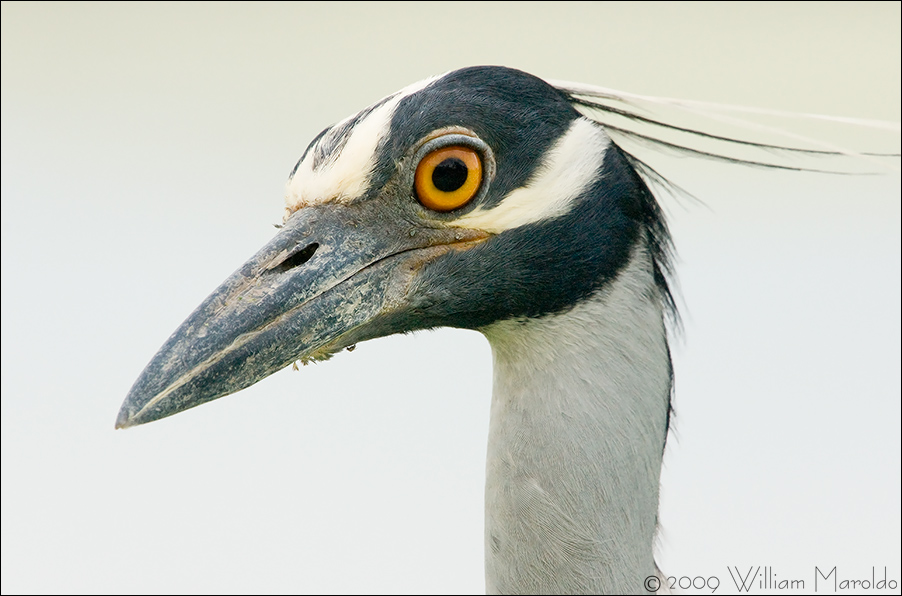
{"left": 413, "top": 145, "right": 482, "bottom": 211}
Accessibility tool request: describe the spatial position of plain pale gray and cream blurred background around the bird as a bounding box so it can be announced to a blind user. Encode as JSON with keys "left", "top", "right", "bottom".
{"left": 0, "top": 2, "right": 900, "bottom": 593}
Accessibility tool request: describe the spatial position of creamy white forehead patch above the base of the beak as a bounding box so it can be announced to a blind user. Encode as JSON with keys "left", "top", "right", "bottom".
{"left": 285, "top": 78, "right": 436, "bottom": 214}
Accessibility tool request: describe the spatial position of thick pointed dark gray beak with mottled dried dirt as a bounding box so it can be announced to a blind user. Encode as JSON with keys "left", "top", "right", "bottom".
{"left": 116, "top": 201, "right": 485, "bottom": 428}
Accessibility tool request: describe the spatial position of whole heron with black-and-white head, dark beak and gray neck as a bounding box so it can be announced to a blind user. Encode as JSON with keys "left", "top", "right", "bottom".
{"left": 117, "top": 67, "right": 888, "bottom": 593}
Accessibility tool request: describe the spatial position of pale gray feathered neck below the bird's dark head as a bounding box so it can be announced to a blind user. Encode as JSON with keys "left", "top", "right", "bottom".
{"left": 483, "top": 247, "right": 672, "bottom": 594}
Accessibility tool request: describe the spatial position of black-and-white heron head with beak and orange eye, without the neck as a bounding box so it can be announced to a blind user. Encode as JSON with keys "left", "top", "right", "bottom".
{"left": 116, "top": 67, "right": 660, "bottom": 427}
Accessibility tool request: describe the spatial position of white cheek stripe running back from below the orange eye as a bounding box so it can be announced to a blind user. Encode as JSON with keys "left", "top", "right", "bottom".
{"left": 448, "top": 118, "right": 611, "bottom": 234}
